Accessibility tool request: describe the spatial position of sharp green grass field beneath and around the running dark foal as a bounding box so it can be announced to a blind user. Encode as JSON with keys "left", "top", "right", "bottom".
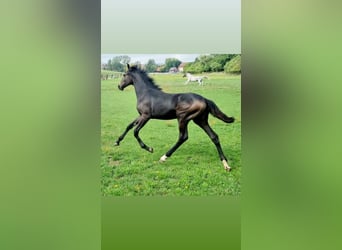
{"left": 101, "top": 73, "right": 241, "bottom": 196}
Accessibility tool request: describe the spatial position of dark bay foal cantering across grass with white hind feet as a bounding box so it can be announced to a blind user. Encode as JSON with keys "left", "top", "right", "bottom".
{"left": 115, "top": 64, "right": 234, "bottom": 171}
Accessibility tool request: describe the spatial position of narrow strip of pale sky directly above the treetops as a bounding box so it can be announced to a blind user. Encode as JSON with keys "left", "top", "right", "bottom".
{"left": 101, "top": 54, "right": 200, "bottom": 64}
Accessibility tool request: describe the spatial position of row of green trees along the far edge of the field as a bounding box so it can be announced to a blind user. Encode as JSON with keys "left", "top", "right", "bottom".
{"left": 102, "top": 54, "right": 241, "bottom": 73}
